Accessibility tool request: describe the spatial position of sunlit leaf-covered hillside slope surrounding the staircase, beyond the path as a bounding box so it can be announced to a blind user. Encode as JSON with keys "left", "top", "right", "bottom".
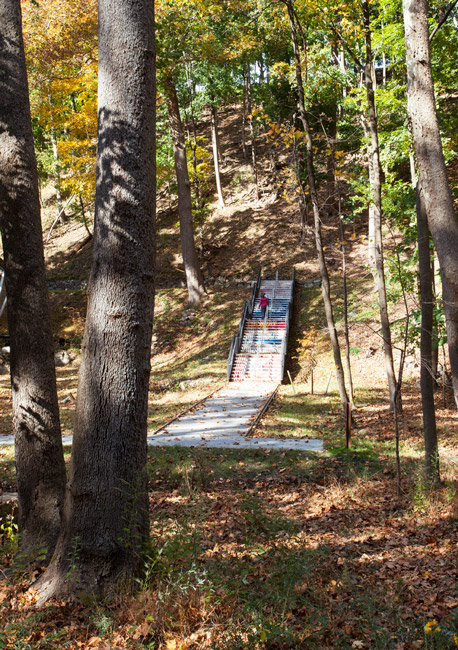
{"left": 0, "top": 102, "right": 452, "bottom": 456}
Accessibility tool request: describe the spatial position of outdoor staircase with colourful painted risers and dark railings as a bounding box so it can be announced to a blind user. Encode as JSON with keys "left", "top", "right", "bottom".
{"left": 227, "top": 269, "right": 295, "bottom": 384}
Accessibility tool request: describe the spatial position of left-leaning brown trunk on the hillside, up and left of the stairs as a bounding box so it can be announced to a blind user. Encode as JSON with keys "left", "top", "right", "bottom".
{"left": 165, "top": 78, "right": 205, "bottom": 307}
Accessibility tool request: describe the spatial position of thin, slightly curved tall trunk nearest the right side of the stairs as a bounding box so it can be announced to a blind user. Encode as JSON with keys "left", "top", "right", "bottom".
{"left": 285, "top": 0, "right": 349, "bottom": 412}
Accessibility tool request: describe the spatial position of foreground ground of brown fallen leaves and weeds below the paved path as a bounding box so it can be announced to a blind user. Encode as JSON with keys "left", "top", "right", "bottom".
{"left": 0, "top": 432, "right": 458, "bottom": 650}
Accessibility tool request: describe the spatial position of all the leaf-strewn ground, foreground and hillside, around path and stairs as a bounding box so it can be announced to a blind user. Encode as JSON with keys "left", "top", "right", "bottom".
{"left": 0, "top": 104, "right": 458, "bottom": 650}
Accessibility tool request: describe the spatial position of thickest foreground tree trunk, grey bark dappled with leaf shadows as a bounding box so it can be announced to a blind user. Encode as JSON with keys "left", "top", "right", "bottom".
{"left": 39, "top": 0, "right": 156, "bottom": 601}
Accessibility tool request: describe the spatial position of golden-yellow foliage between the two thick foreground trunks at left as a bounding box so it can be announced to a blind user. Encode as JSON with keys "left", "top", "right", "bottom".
{"left": 23, "top": 0, "right": 97, "bottom": 200}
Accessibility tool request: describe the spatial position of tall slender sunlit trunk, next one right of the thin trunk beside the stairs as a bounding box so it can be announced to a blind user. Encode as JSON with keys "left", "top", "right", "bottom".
{"left": 362, "top": 0, "right": 401, "bottom": 411}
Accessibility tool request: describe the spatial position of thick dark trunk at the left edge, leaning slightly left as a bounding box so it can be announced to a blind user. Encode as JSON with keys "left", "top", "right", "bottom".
{"left": 0, "top": 0, "right": 65, "bottom": 559}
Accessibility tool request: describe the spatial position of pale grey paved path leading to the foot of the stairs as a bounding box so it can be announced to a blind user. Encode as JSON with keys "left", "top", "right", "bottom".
{"left": 0, "top": 382, "right": 323, "bottom": 451}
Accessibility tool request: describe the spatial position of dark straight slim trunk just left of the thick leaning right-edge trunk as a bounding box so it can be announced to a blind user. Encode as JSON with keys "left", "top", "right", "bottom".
{"left": 417, "top": 184, "right": 440, "bottom": 483}
